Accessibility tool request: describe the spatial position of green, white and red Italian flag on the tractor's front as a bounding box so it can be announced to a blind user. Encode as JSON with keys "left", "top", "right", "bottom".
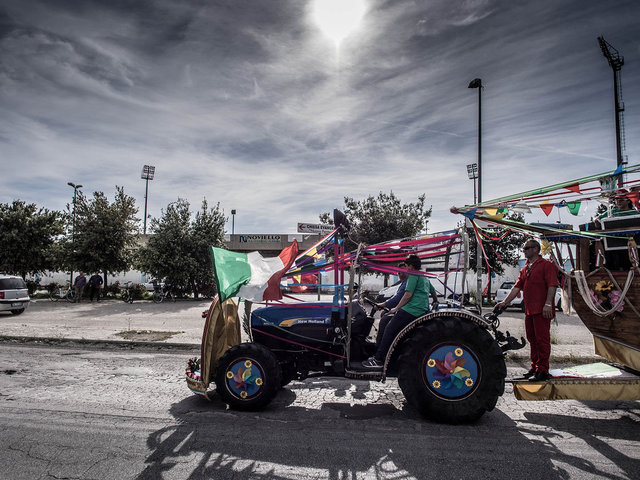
{"left": 211, "top": 240, "right": 298, "bottom": 302}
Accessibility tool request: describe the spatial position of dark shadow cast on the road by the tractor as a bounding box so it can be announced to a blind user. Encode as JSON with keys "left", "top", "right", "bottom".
{"left": 137, "top": 384, "right": 576, "bottom": 480}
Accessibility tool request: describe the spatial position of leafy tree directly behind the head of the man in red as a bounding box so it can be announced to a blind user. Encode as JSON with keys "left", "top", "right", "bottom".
{"left": 467, "top": 213, "right": 527, "bottom": 298}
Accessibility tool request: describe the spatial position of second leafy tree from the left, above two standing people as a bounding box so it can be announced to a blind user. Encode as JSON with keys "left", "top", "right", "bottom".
{"left": 65, "top": 186, "right": 139, "bottom": 285}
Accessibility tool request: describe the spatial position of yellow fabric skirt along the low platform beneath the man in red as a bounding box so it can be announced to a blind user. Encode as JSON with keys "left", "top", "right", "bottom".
{"left": 513, "top": 378, "right": 640, "bottom": 400}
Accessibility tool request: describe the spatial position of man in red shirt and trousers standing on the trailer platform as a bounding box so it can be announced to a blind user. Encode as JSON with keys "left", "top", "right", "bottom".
{"left": 496, "top": 239, "right": 558, "bottom": 382}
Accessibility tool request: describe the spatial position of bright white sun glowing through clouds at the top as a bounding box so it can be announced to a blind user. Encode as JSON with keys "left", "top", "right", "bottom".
{"left": 313, "top": 0, "right": 364, "bottom": 46}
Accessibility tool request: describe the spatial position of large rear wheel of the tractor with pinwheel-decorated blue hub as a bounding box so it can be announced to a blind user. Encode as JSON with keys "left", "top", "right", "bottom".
{"left": 398, "top": 317, "right": 507, "bottom": 424}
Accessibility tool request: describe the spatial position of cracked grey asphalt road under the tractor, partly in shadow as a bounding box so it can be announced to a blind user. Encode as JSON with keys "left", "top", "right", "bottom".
{"left": 0, "top": 343, "right": 640, "bottom": 480}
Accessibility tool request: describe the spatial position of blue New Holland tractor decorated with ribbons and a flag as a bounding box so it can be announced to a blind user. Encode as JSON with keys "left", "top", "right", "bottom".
{"left": 186, "top": 211, "right": 525, "bottom": 423}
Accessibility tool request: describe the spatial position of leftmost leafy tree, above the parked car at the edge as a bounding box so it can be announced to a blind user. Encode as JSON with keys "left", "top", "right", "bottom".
{"left": 0, "top": 200, "right": 64, "bottom": 278}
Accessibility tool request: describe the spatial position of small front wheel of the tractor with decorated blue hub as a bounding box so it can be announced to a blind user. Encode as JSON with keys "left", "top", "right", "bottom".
{"left": 216, "top": 343, "right": 282, "bottom": 410}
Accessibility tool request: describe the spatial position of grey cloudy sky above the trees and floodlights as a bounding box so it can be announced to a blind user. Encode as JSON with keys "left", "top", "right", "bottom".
{"left": 0, "top": 0, "right": 640, "bottom": 233}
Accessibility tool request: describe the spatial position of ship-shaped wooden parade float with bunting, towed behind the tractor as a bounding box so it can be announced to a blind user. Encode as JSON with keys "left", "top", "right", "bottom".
{"left": 452, "top": 165, "right": 640, "bottom": 400}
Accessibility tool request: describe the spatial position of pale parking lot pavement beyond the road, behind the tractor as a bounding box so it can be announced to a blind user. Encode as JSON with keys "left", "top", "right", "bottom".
{"left": 0, "top": 294, "right": 597, "bottom": 361}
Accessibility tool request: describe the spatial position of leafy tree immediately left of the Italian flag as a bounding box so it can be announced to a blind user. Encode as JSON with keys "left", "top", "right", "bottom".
{"left": 136, "top": 199, "right": 226, "bottom": 296}
